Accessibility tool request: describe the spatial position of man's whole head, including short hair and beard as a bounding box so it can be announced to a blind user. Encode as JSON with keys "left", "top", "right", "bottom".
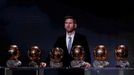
{"left": 64, "top": 16, "right": 77, "bottom": 33}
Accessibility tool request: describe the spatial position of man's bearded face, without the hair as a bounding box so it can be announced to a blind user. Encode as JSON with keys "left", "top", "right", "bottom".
{"left": 64, "top": 19, "right": 76, "bottom": 32}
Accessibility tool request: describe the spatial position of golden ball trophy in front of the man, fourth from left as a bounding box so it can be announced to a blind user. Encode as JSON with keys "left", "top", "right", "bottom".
{"left": 71, "top": 45, "right": 87, "bottom": 67}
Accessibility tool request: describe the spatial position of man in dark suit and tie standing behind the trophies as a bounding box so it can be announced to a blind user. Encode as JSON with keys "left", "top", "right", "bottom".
{"left": 54, "top": 16, "right": 91, "bottom": 67}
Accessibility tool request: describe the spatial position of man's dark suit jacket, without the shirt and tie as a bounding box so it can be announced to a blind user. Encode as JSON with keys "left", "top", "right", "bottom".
{"left": 54, "top": 33, "right": 91, "bottom": 67}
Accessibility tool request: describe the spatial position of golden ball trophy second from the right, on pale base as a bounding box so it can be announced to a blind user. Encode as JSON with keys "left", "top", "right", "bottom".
{"left": 93, "top": 45, "right": 109, "bottom": 68}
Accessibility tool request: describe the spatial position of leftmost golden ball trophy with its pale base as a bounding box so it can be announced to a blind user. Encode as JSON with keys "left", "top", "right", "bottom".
{"left": 6, "top": 45, "right": 21, "bottom": 67}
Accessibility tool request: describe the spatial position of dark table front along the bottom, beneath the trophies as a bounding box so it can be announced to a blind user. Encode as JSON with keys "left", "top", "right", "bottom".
{"left": 0, "top": 67, "right": 134, "bottom": 75}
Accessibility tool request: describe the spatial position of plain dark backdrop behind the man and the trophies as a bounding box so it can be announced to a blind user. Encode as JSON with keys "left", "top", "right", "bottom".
{"left": 0, "top": 0, "right": 134, "bottom": 67}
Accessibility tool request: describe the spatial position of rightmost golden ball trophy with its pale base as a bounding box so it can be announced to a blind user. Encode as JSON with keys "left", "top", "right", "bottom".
{"left": 115, "top": 45, "right": 129, "bottom": 68}
